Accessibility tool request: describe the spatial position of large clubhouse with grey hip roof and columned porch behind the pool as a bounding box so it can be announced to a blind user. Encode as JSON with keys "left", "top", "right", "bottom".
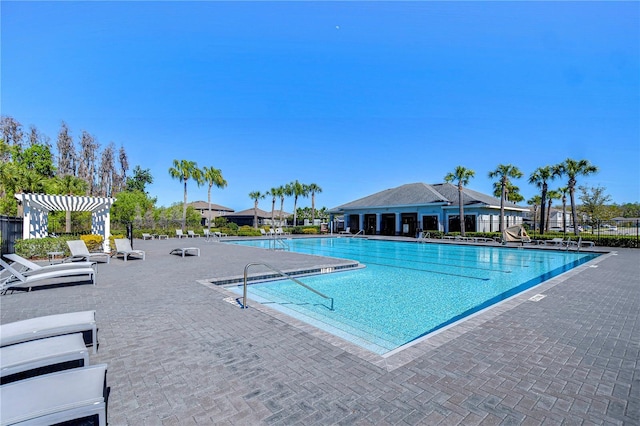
{"left": 329, "top": 183, "right": 528, "bottom": 236}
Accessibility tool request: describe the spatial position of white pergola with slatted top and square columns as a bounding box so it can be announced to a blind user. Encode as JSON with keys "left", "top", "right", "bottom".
{"left": 15, "top": 194, "right": 116, "bottom": 253}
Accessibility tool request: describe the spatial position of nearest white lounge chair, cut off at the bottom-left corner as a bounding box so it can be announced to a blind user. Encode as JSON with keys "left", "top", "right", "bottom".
{"left": 0, "top": 364, "right": 109, "bottom": 426}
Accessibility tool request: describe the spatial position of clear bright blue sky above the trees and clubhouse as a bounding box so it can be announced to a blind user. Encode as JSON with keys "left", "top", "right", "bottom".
{"left": 0, "top": 1, "right": 640, "bottom": 211}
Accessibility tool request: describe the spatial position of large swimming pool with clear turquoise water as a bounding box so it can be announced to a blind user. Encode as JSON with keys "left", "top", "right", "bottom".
{"left": 228, "top": 238, "right": 597, "bottom": 354}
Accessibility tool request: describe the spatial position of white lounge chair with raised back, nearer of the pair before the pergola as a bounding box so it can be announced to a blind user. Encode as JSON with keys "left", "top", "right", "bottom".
{"left": 0, "top": 259, "right": 96, "bottom": 294}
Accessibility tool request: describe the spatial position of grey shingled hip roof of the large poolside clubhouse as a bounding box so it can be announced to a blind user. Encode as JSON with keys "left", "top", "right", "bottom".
{"left": 331, "top": 182, "right": 526, "bottom": 212}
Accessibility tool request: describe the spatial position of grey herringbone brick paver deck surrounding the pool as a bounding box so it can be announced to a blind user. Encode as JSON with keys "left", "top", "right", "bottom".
{"left": 0, "top": 238, "right": 640, "bottom": 425}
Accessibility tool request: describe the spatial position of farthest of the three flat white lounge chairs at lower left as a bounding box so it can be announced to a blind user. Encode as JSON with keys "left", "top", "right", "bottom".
{"left": 0, "top": 311, "right": 98, "bottom": 353}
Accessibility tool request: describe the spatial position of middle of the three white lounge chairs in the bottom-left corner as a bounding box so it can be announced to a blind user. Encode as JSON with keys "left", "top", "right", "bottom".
{"left": 0, "top": 333, "right": 89, "bottom": 385}
